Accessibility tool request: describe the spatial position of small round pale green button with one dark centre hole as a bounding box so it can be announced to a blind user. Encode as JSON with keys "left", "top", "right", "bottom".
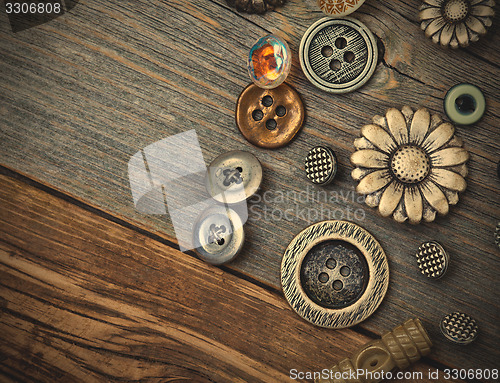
{"left": 444, "top": 84, "right": 486, "bottom": 125}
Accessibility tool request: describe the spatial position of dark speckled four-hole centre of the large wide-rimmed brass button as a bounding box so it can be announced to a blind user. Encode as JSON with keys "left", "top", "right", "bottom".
{"left": 300, "top": 240, "right": 368, "bottom": 308}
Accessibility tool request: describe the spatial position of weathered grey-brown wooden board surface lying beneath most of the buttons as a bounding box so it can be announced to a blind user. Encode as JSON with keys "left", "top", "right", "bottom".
{"left": 0, "top": 0, "right": 500, "bottom": 374}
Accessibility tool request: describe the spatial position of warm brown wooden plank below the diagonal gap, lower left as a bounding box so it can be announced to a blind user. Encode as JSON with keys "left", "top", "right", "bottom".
{"left": 0, "top": 175, "right": 454, "bottom": 382}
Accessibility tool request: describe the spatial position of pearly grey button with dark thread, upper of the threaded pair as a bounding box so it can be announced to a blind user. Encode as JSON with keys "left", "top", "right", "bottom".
{"left": 205, "top": 150, "right": 262, "bottom": 204}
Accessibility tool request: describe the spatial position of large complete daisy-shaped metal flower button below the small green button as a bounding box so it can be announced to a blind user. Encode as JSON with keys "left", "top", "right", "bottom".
{"left": 351, "top": 106, "right": 469, "bottom": 224}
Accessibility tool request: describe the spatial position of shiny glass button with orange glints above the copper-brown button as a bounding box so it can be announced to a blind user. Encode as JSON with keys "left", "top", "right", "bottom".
{"left": 248, "top": 35, "right": 292, "bottom": 89}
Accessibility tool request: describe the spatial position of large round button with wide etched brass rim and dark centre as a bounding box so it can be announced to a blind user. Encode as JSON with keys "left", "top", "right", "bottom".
{"left": 281, "top": 221, "right": 389, "bottom": 328}
